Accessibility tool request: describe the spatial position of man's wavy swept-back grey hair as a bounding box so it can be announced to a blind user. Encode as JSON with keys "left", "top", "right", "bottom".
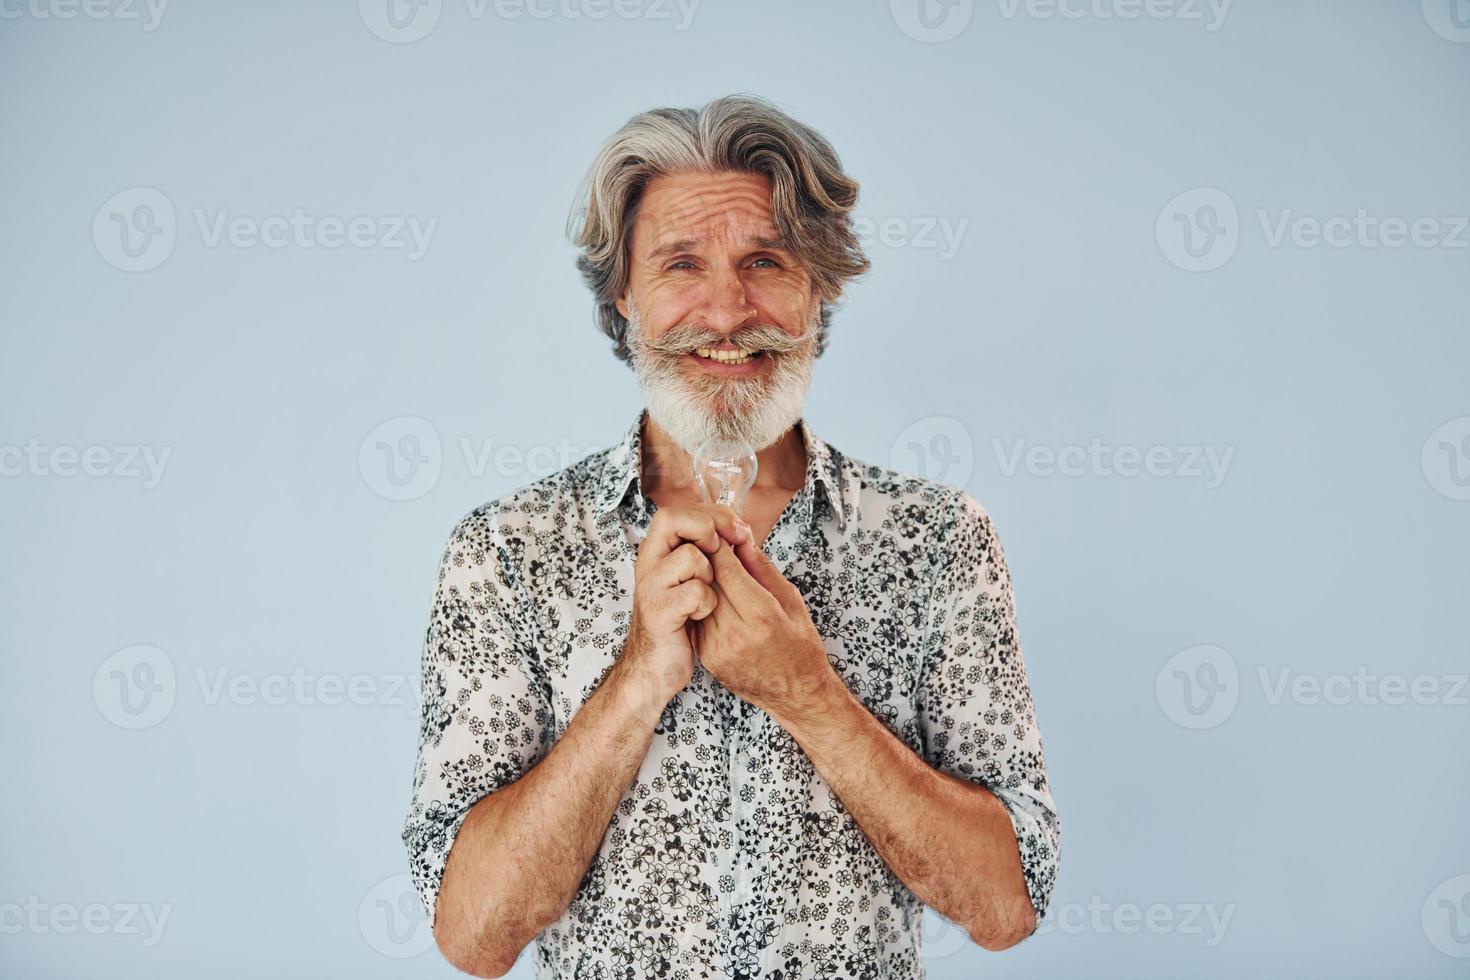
{"left": 567, "top": 96, "right": 870, "bottom": 364}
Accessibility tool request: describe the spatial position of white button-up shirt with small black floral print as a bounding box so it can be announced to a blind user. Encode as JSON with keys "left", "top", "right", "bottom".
{"left": 403, "top": 411, "right": 1058, "bottom": 980}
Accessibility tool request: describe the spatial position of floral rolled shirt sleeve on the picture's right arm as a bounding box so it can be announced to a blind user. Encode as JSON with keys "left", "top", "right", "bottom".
{"left": 916, "top": 491, "right": 1060, "bottom": 921}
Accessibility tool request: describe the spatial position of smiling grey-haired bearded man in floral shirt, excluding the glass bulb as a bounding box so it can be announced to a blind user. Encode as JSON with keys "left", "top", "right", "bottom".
{"left": 403, "top": 97, "right": 1058, "bottom": 980}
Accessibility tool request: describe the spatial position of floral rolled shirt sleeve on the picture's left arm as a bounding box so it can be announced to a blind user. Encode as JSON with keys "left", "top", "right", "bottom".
{"left": 403, "top": 505, "right": 553, "bottom": 924}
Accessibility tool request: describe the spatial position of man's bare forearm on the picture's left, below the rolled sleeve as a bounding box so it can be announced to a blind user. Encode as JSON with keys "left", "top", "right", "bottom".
{"left": 434, "top": 660, "right": 667, "bottom": 977}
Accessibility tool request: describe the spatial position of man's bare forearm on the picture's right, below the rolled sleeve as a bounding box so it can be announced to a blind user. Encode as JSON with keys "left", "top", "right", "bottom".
{"left": 772, "top": 671, "right": 1036, "bottom": 949}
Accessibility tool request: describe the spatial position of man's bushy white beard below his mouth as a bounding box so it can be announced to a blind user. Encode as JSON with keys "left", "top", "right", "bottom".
{"left": 628, "top": 301, "right": 820, "bottom": 455}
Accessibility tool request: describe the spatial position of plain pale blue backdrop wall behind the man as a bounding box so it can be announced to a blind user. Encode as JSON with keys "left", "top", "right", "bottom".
{"left": 0, "top": 0, "right": 1470, "bottom": 979}
